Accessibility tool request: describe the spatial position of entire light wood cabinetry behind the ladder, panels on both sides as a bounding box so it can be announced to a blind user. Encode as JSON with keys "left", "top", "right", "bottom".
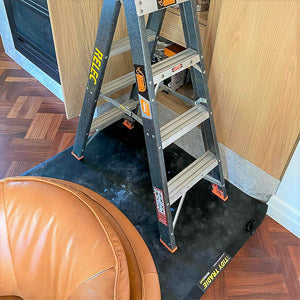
{"left": 48, "top": 0, "right": 300, "bottom": 179}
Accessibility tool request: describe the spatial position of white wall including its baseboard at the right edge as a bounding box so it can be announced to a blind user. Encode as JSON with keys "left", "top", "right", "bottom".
{"left": 268, "top": 143, "right": 300, "bottom": 238}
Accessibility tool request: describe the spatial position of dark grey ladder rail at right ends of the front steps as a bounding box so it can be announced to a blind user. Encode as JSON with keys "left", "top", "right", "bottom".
{"left": 179, "top": 0, "right": 227, "bottom": 197}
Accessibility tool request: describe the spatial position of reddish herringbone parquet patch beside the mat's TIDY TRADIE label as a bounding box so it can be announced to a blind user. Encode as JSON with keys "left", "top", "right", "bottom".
{"left": 203, "top": 217, "right": 300, "bottom": 300}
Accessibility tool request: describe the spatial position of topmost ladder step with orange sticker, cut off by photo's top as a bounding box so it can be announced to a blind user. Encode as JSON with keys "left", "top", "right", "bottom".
{"left": 135, "top": 0, "right": 188, "bottom": 16}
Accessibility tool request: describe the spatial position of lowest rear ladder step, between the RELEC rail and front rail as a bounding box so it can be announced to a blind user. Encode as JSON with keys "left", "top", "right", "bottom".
{"left": 91, "top": 101, "right": 139, "bottom": 132}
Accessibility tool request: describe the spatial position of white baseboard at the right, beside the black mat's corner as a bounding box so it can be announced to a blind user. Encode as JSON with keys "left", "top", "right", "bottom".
{"left": 267, "top": 195, "right": 300, "bottom": 238}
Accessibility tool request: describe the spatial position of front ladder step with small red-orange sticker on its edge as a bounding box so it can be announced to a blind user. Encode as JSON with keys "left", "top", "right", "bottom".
{"left": 152, "top": 48, "right": 200, "bottom": 84}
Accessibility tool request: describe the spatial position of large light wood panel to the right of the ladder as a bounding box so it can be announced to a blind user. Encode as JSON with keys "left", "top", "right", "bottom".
{"left": 209, "top": 0, "right": 300, "bottom": 179}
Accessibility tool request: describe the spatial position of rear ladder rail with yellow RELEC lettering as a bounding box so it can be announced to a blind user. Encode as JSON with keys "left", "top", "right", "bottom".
{"left": 72, "top": 0, "right": 121, "bottom": 159}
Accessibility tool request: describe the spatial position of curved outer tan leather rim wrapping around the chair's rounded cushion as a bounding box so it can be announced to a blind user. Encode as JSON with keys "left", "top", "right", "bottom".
{"left": 48, "top": 179, "right": 161, "bottom": 300}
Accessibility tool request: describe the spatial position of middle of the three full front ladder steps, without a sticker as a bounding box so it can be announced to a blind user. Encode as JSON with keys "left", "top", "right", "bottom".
{"left": 161, "top": 104, "right": 209, "bottom": 149}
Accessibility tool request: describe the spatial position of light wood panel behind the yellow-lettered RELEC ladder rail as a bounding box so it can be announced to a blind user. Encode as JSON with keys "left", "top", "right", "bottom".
{"left": 48, "top": 0, "right": 132, "bottom": 118}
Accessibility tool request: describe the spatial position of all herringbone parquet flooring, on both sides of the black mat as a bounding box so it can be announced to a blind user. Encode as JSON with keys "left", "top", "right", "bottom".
{"left": 0, "top": 40, "right": 300, "bottom": 300}
